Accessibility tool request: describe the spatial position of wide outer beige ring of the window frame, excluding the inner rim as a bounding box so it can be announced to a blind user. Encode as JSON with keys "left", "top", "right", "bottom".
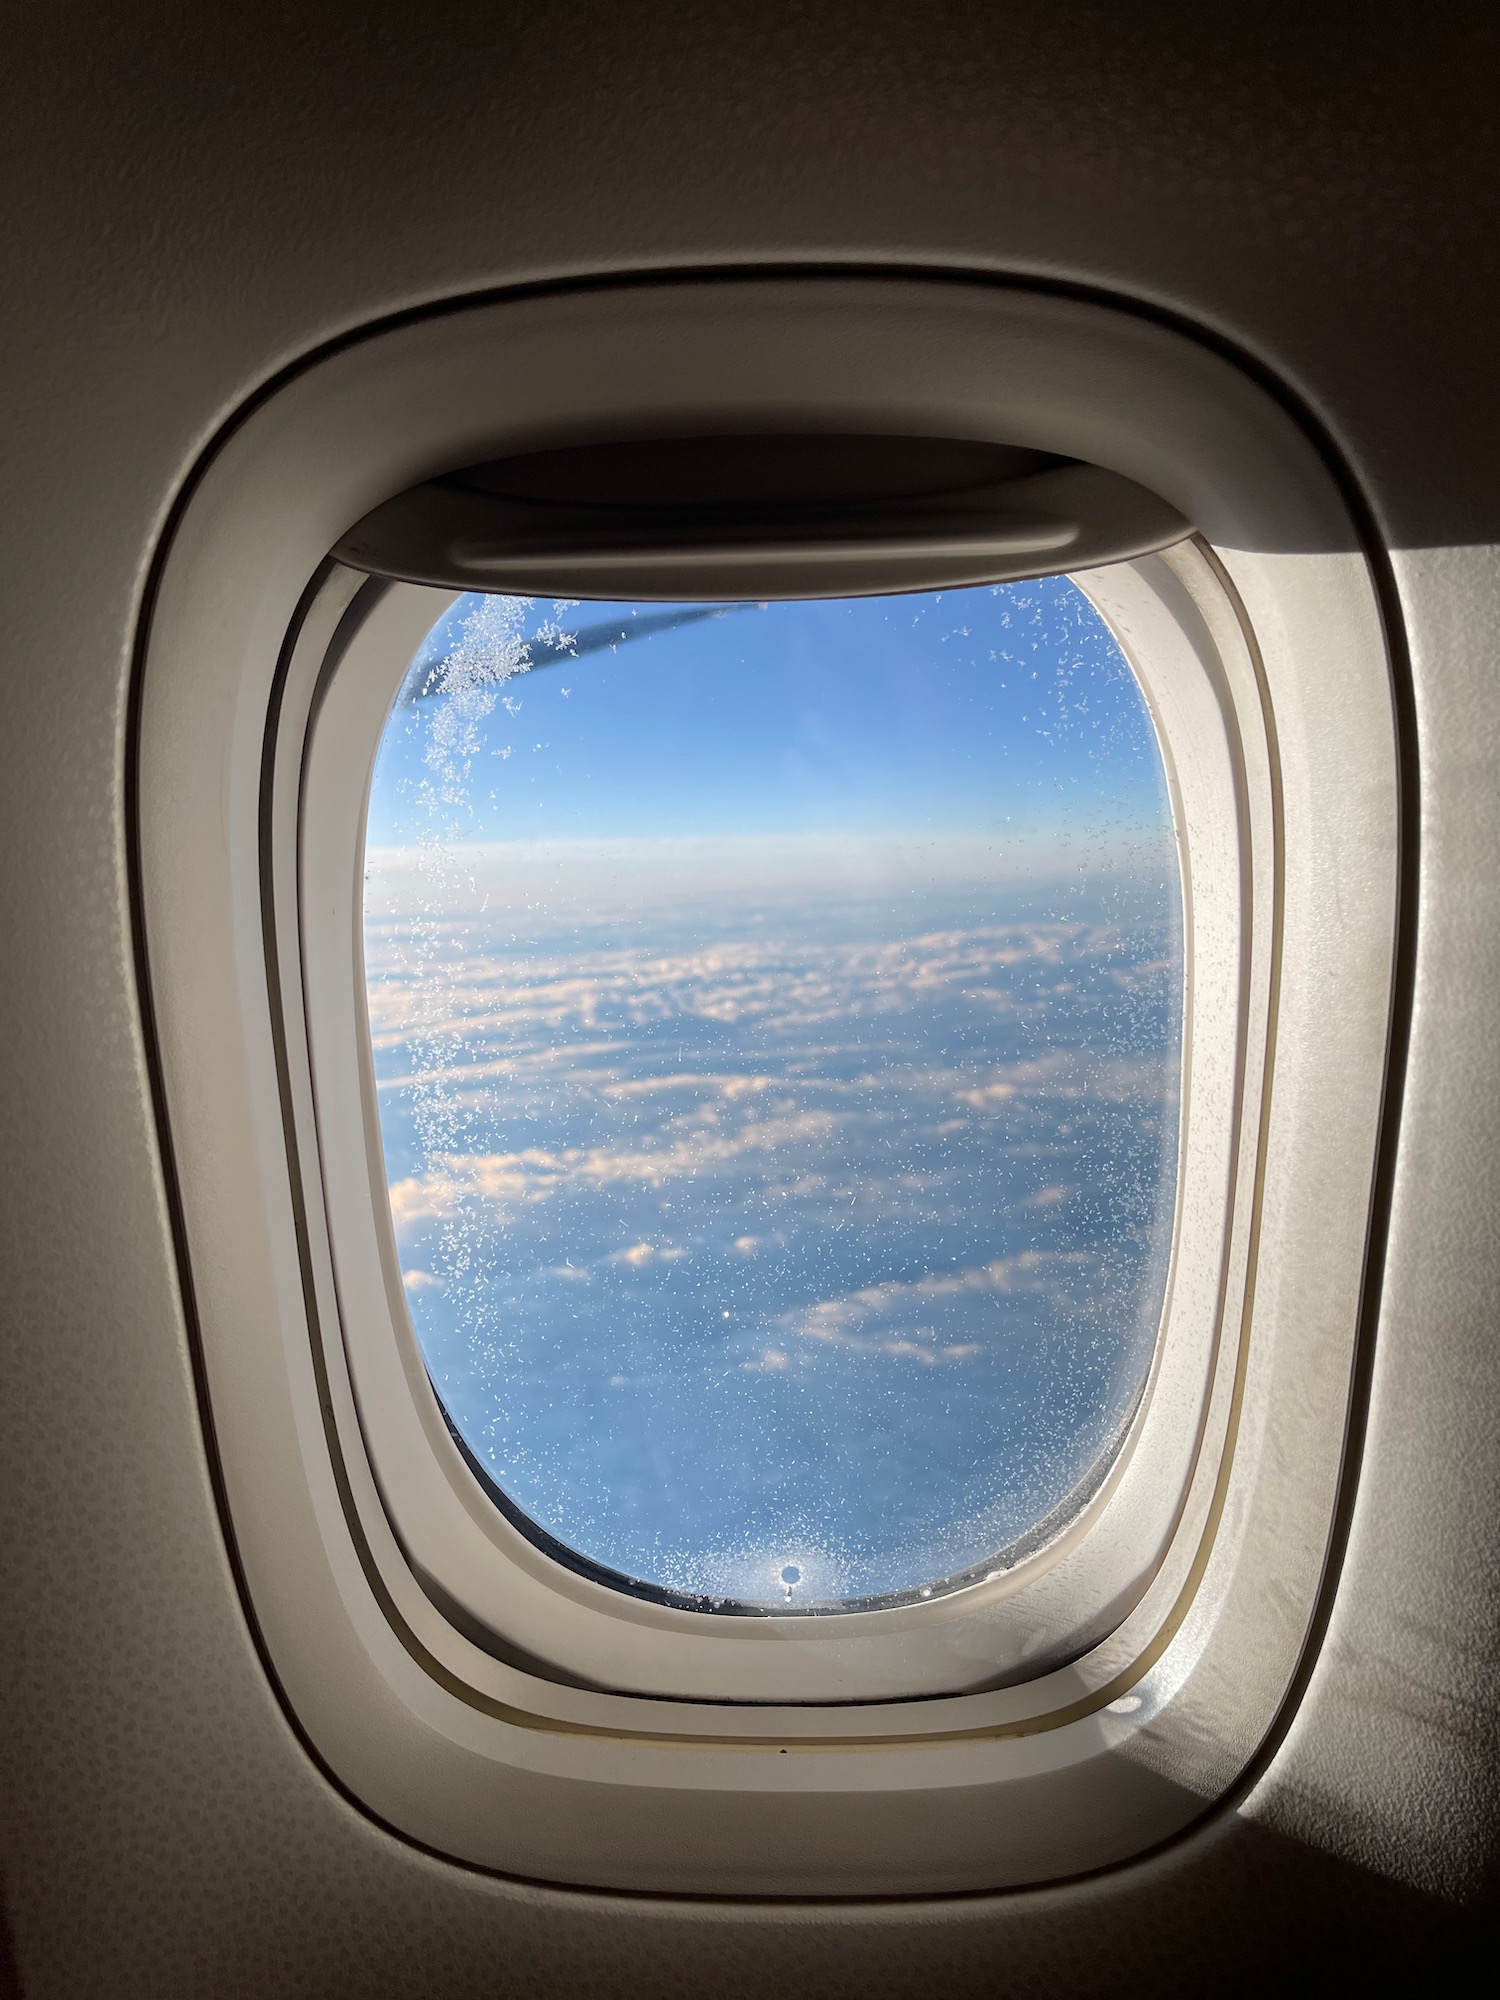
{"left": 138, "top": 278, "right": 1398, "bottom": 1896}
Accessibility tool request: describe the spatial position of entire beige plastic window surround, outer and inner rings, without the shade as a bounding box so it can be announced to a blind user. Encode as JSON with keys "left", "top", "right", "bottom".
{"left": 140, "top": 280, "right": 1396, "bottom": 1894}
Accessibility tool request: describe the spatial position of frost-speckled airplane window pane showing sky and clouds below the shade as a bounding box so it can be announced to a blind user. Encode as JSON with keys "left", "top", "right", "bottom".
{"left": 364, "top": 578, "right": 1182, "bottom": 1614}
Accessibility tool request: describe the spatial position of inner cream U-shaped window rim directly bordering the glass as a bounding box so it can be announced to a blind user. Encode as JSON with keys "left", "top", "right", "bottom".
{"left": 294, "top": 548, "right": 1248, "bottom": 1704}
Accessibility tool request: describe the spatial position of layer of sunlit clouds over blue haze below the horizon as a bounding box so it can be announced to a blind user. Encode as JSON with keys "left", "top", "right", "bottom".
{"left": 368, "top": 896, "right": 1178, "bottom": 1602}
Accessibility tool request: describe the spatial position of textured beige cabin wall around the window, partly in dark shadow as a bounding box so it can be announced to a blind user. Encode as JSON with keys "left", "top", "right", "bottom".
{"left": 0, "top": 0, "right": 1500, "bottom": 2000}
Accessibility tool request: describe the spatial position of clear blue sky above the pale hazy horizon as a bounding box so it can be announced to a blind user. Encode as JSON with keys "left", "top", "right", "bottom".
{"left": 368, "top": 578, "right": 1164, "bottom": 864}
